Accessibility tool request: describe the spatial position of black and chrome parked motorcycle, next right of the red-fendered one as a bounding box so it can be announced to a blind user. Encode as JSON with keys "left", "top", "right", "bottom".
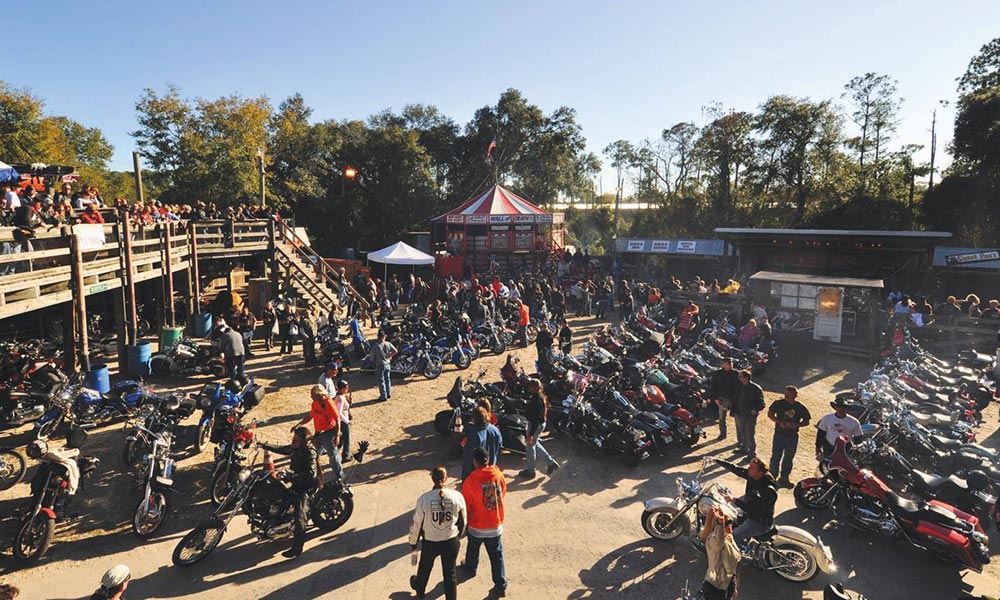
{"left": 132, "top": 426, "right": 176, "bottom": 540}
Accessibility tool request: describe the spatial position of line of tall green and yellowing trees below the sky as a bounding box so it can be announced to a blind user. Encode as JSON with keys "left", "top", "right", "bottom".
{"left": 0, "top": 38, "right": 1000, "bottom": 254}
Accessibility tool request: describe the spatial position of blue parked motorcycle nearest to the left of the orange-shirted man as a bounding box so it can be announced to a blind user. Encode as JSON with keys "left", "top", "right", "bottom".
{"left": 194, "top": 375, "right": 264, "bottom": 453}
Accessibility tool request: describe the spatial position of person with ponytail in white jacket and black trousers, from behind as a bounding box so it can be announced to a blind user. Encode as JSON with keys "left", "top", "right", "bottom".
{"left": 409, "top": 466, "right": 467, "bottom": 600}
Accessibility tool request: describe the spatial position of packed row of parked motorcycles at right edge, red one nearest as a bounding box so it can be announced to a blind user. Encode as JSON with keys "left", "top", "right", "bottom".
{"left": 794, "top": 332, "right": 1000, "bottom": 572}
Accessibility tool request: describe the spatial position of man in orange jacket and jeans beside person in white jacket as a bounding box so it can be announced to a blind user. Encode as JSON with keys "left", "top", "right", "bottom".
{"left": 461, "top": 448, "right": 507, "bottom": 598}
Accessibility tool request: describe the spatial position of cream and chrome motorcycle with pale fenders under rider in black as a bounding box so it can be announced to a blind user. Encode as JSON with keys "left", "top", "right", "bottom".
{"left": 642, "top": 458, "right": 835, "bottom": 582}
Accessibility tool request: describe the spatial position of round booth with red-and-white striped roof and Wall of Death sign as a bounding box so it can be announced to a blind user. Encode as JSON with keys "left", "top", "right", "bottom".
{"left": 431, "top": 185, "right": 564, "bottom": 274}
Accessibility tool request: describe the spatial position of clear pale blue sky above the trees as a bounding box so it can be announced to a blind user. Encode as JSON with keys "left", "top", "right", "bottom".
{"left": 0, "top": 0, "right": 1000, "bottom": 190}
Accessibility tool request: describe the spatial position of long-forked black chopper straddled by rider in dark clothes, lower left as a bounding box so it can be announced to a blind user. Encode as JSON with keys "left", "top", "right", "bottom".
{"left": 173, "top": 441, "right": 368, "bottom": 567}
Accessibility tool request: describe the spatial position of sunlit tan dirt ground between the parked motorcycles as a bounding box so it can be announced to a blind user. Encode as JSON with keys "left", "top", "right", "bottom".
{"left": 0, "top": 320, "right": 1000, "bottom": 600}
